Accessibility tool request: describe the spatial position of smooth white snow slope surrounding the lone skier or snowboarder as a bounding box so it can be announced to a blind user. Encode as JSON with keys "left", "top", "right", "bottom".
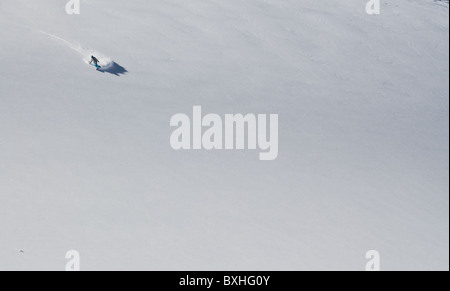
{"left": 0, "top": 0, "right": 449, "bottom": 270}
